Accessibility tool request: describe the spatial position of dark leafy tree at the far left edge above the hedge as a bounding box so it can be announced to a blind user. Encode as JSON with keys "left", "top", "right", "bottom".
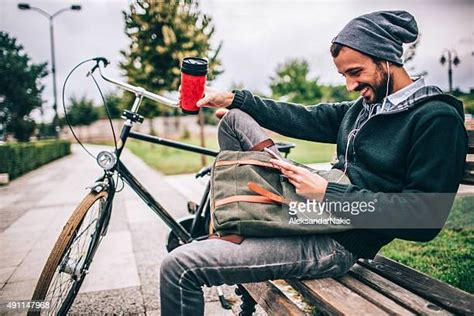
{"left": 0, "top": 32, "right": 47, "bottom": 141}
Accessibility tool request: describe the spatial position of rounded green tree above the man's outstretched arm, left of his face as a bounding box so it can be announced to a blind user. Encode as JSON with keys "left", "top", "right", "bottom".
{"left": 270, "top": 59, "right": 322, "bottom": 104}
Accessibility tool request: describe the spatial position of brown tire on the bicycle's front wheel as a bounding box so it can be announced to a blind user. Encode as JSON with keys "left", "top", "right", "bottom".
{"left": 28, "top": 191, "right": 108, "bottom": 314}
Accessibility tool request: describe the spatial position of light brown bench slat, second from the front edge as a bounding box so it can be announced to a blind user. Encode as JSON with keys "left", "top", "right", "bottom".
{"left": 286, "top": 278, "right": 388, "bottom": 315}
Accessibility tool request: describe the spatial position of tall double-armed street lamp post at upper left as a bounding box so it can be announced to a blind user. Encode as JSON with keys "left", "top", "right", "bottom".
{"left": 18, "top": 3, "right": 81, "bottom": 137}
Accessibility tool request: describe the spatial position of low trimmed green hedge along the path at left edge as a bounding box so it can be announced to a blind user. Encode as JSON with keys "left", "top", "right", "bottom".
{"left": 0, "top": 140, "right": 71, "bottom": 179}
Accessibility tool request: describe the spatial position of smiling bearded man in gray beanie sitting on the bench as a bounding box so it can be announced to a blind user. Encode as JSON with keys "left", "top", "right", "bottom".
{"left": 160, "top": 11, "right": 467, "bottom": 315}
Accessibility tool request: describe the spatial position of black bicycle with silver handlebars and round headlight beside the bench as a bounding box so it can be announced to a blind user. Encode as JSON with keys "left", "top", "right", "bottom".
{"left": 28, "top": 57, "right": 294, "bottom": 315}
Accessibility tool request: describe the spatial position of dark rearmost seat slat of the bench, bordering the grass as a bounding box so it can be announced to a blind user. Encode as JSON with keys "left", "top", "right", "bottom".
{"left": 360, "top": 256, "right": 474, "bottom": 315}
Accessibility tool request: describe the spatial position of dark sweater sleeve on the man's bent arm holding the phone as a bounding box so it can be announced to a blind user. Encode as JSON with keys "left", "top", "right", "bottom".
{"left": 325, "top": 115, "right": 467, "bottom": 241}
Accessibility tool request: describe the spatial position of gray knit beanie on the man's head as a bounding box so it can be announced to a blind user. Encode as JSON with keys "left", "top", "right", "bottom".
{"left": 332, "top": 11, "right": 418, "bottom": 66}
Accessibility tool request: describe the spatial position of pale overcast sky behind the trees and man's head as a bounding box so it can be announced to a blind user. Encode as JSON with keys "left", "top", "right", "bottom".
{"left": 0, "top": 0, "right": 474, "bottom": 121}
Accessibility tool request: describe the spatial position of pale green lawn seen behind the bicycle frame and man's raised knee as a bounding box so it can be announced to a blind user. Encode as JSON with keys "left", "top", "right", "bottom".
{"left": 126, "top": 136, "right": 335, "bottom": 175}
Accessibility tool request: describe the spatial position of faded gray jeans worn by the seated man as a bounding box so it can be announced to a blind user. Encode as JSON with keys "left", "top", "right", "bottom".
{"left": 160, "top": 109, "right": 357, "bottom": 315}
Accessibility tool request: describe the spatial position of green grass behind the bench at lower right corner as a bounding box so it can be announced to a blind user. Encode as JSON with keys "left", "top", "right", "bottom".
{"left": 381, "top": 196, "right": 474, "bottom": 294}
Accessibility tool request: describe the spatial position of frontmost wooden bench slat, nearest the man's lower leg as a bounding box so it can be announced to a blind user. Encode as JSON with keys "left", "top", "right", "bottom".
{"left": 242, "top": 281, "right": 305, "bottom": 316}
